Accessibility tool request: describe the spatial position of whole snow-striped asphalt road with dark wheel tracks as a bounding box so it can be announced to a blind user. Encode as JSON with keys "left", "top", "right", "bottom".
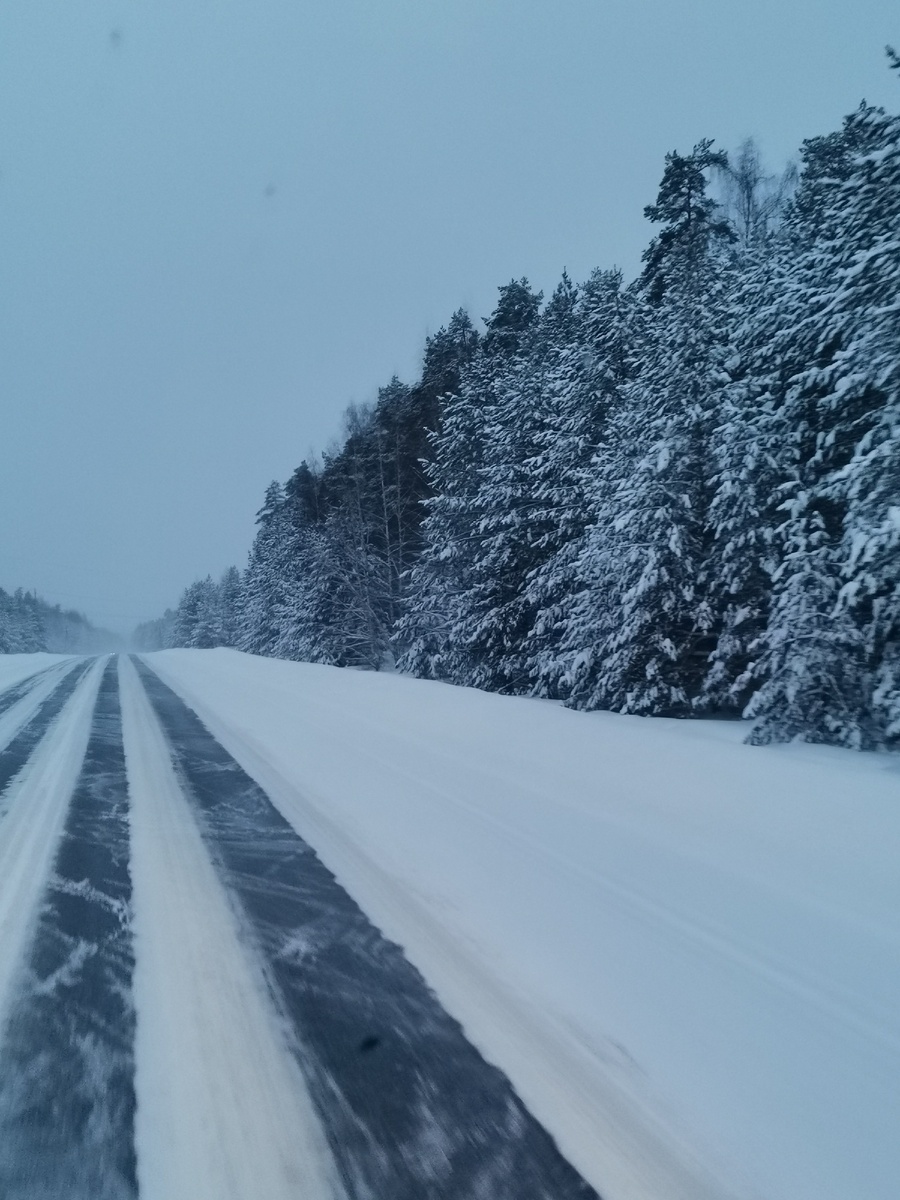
{"left": 0, "top": 658, "right": 607, "bottom": 1200}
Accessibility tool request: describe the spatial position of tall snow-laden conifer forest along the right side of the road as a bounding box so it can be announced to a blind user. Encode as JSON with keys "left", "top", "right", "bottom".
{"left": 148, "top": 63, "right": 900, "bottom": 749}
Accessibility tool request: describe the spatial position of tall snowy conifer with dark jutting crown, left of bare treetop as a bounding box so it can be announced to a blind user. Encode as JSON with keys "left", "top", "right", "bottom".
{"left": 572, "top": 142, "right": 732, "bottom": 715}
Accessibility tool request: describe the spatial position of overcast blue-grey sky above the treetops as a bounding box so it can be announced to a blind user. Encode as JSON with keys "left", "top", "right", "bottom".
{"left": 0, "top": 0, "right": 900, "bottom": 629}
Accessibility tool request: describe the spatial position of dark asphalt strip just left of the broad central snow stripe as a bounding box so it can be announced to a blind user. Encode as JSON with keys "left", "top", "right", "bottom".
{"left": 0, "top": 659, "right": 137, "bottom": 1200}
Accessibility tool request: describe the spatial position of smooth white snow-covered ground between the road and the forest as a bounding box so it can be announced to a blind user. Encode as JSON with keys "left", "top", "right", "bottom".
{"left": 148, "top": 650, "right": 900, "bottom": 1200}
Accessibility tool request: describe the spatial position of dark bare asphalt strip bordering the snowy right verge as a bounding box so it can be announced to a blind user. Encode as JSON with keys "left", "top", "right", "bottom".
{"left": 137, "top": 662, "right": 596, "bottom": 1200}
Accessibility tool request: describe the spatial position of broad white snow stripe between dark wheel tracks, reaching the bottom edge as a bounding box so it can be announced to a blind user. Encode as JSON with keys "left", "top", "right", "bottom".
{"left": 119, "top": 656, "right": 342, "bottom": 1200}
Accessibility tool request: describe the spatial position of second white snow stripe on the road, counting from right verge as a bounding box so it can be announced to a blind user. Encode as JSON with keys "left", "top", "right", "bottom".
{"left": 0, "top": 660, "right": 106, "bottom": 1036}
